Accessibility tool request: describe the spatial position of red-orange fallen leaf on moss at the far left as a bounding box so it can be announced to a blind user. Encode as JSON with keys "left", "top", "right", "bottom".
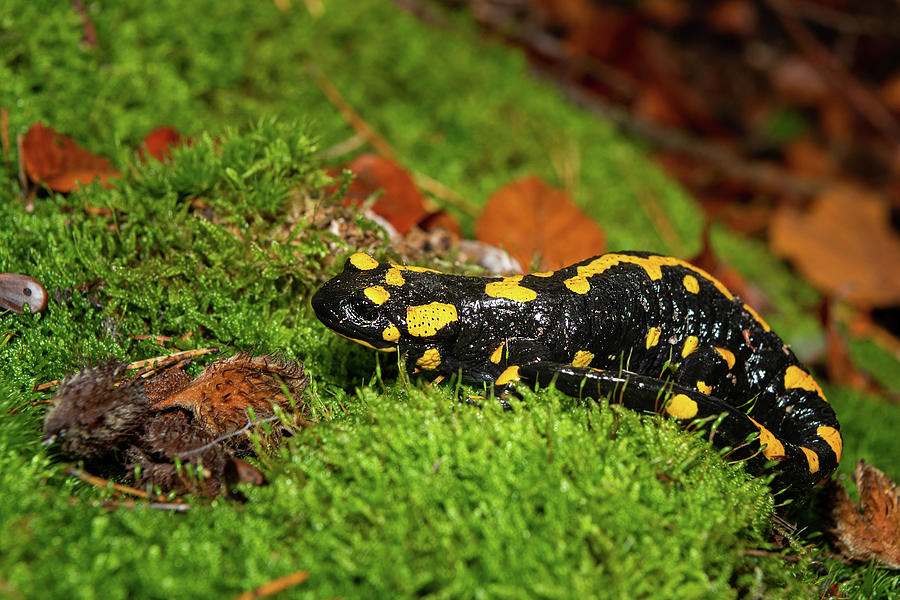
{"left": 22, "top": 123, "right": 119, "bottom": 192}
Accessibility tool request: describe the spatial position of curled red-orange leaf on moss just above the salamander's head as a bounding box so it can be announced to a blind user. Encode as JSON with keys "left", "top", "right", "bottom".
{"left": 344, "top": 154, "right": 428, "bottom": 235}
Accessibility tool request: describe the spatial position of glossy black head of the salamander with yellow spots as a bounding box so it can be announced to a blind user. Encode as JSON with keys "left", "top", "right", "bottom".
{"left": 312, "top": 253, "right": 458, "bottom": 352}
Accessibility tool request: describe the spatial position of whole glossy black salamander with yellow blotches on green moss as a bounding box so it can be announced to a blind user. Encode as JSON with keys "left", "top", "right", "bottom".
{"left": 312, "top": 252, "right": 842, "bottom": 489}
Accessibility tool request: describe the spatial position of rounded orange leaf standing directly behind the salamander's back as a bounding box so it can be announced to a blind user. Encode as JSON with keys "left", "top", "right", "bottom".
{"left": 475, "top": 176, "right": 606, "bottom": 269}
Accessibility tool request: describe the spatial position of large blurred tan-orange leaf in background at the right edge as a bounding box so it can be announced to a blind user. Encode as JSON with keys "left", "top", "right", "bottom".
{"left": 769, "top": 186, "right": 900, "bottom": 307}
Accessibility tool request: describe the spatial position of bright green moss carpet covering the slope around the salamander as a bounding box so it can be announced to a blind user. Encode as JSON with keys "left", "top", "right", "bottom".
{"left": 0, "top": 0, "right": 900, "bottom": 598}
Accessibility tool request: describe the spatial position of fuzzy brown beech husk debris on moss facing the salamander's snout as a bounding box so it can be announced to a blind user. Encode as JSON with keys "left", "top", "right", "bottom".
{"left": 44, "top": 354, "right": 307, "bottom": 497}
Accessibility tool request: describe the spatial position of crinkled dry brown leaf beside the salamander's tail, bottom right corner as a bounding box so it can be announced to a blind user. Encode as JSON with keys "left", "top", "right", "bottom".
{"left": 831, "top": 460, "right": 900, "bottom": 569}
